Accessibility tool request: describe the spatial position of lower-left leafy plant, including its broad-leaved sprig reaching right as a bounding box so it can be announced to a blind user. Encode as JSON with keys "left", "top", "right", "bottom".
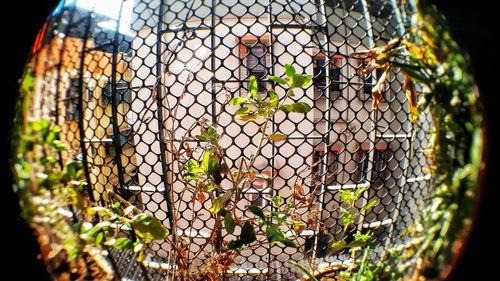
{"left": 14, "top": 116, "right": 168, "bottom": 280}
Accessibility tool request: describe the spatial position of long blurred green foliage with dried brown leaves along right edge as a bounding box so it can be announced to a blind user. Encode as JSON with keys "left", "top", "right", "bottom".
{"left": 308, "top": 0, "right": 482, "bottom": 280}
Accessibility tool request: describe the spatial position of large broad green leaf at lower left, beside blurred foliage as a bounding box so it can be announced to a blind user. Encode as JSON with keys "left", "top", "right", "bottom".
{"left": 131, "top": 213, "right": 168, "bottom": 240}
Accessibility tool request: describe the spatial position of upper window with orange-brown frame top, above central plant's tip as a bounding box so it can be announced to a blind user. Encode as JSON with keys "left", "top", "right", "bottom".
{"left": 240, "top": 35, "right": 271, "bottom": 91}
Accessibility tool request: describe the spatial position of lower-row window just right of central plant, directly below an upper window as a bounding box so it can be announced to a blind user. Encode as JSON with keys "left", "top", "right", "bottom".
{"left": 312, "top": 146, "right": 342, "bottom": 185}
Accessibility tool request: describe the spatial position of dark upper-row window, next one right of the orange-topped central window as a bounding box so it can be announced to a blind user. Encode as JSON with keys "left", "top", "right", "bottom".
{"left": 313, "top": 53, "right": 342, "bottom": 99}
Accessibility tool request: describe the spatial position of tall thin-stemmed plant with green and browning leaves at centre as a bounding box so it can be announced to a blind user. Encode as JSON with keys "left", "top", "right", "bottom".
{"left": 158, "top": 65, "right": 312, "bottom": 280}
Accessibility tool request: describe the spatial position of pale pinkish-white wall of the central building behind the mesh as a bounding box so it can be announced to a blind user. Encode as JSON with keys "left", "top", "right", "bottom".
{"left": 131, "top": 7, "right": 409, "bottom": 260}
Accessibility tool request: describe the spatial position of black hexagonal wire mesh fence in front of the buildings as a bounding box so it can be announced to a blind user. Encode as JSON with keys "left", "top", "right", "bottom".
{"left": 24, "top": 0, "right": 432, "bottom": 280}
